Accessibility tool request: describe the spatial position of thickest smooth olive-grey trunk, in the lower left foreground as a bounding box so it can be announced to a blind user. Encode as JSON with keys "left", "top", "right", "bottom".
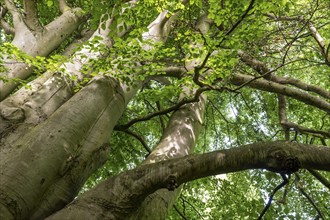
{"left": 0, "top": 8, "right": 180, "bottom": 219}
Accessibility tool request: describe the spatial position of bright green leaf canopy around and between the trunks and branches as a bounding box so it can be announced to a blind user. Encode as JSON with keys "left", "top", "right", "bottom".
{"left": 0, "top": 0, "right": 330, "bottom": 219}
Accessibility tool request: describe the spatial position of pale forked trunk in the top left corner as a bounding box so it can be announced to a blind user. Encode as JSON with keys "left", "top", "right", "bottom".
{"left": 0, "top": 0, "right": 84, "bottom": 101}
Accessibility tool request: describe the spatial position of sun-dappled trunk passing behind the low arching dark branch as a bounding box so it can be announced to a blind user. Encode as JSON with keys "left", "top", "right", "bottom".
{"left": 130, "top": 93, "right": 206, "bottom": 220}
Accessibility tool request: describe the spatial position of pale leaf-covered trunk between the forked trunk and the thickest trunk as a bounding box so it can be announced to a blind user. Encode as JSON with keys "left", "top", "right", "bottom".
{"left": 0, "top": 12, "right": 112, "bottom": 148}
